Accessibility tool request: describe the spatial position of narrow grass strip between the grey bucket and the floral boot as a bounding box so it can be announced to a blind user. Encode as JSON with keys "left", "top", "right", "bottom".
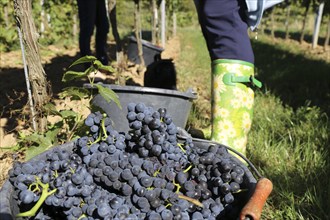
{"left": 176, "top": 27, "right": 211, "bottom": 129}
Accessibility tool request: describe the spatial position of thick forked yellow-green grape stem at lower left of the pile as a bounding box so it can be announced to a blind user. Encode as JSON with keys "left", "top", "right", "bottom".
{"left": 16, "top": 178, "right": 57, "bottom": 217}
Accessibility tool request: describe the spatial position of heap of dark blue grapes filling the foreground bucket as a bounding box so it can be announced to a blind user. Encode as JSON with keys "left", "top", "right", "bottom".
{"left": 9, "top": 103, "right": 251, "bottom": 220}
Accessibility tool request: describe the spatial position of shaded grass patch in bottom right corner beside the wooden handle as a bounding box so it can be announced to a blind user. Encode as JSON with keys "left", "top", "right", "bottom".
{"left": 267, "top": 163, "right": 330, "bottom": 219}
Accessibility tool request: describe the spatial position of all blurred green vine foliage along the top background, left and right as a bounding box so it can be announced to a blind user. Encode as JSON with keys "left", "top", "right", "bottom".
{"left": 0, "top": 0, "right": 330, "bottom": 51}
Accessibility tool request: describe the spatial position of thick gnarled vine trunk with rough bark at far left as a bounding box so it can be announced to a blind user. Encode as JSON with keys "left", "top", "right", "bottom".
{"left": 14, "top": 0, "right": 50, "bottom": 132}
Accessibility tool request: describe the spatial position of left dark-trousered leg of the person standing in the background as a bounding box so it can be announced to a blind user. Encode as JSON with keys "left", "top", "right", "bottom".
{"left": 78, "top": 0, "right": 96, "bottom": 56}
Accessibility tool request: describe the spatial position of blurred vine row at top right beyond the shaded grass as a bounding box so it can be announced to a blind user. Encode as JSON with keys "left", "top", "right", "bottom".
{"left": 260, "top": 0, "right": 330, "bottom": 48}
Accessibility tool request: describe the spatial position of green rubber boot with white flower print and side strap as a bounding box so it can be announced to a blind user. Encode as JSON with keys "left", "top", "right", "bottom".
{"left": 211, "top": 59, "right": 261, "bottom": 155}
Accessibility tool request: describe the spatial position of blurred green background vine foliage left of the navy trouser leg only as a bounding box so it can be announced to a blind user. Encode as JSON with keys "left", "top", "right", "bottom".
{"left": 0, "top": 0, "right": 195, "bottom": 52}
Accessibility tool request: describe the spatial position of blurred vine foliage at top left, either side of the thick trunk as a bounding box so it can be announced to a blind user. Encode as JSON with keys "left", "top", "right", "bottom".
{"left": 0, "top": 0, "right": 79, "bottom": 51}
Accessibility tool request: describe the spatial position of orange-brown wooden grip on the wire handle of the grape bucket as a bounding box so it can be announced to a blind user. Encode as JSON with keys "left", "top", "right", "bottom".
{"left": 239, "top": 178, "right": 273, "bottom": 220}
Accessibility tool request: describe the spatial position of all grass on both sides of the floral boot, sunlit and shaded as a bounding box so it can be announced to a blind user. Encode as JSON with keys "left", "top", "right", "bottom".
{"left": 176, "top": 28, "right": 330, "bottom": 219}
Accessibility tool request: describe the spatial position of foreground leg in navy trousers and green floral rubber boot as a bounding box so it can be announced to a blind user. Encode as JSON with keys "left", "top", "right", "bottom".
{"left": 202, "top": 0, "right": 260, "bottom": 154}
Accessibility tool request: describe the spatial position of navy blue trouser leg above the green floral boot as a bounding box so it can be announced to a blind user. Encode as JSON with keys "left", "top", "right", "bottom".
{"left": 203, "top": 0, "right": 254, "bottom": 63}
